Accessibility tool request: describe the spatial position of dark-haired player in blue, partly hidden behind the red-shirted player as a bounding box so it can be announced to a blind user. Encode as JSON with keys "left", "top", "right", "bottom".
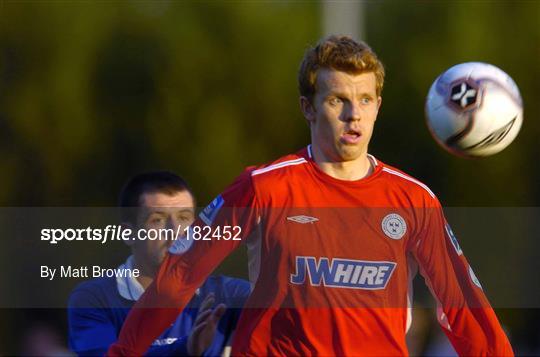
{"left": 68, "top": 172, "right": 250, "bottom": 356}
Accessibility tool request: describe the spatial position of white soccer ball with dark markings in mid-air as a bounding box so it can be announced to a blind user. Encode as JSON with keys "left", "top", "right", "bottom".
{"left": 425, "top": 62, "right": 523, "bottom": 157}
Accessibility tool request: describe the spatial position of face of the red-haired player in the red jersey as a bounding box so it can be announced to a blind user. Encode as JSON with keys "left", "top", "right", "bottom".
{"left": 301, "top": 68, "right": 381, "bottom": 162}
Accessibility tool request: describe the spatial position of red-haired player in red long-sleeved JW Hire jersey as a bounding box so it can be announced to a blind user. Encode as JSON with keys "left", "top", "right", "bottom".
{"left": 109, "top": 36, "right": 512, "bottom": 356}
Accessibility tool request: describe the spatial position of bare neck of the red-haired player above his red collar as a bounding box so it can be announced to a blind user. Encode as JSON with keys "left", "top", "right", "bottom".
{"left": 313, "top": 149, "right": 373, "bottom": 181}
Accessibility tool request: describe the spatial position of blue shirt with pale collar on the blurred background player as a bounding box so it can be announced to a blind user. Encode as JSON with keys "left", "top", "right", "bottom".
{"left": 68, "top": 260, "right": 250, "bottom": 356}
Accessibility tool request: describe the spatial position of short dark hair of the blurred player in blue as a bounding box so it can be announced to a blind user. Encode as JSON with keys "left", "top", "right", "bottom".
{"left": 118, "top": 171, "right": 195, "bottom": 223}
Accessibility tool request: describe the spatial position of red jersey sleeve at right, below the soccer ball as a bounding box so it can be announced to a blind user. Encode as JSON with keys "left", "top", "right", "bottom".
{"left": 412, "top": 199, "right": 513, "bottom": 356}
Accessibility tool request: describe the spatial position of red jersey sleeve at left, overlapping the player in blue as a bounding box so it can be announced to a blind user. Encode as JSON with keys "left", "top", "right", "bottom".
{"left": 108, "top": 170, "right": 259, "bottom": 356}
